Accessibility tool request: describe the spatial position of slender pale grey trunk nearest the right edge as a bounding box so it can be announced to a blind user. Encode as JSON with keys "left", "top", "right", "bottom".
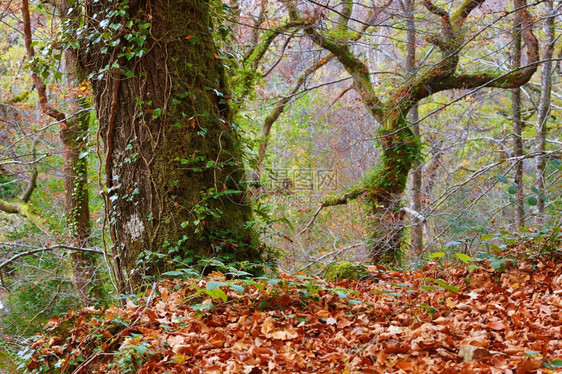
{"left": 535, "top": 0, "right": 556, "bottom": 224}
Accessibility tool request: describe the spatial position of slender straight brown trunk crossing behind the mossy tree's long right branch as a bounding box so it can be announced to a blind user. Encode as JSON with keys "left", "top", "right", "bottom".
{"left": 511, "top": 16, "right": 525, "bottom": 228}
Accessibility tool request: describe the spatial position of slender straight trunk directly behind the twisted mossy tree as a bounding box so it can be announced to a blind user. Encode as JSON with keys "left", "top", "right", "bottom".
{"left": 403, "top": 0, "right": 423, "bottom": 253}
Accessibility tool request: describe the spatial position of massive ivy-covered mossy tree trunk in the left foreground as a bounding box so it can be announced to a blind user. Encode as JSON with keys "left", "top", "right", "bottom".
{"left": 83, "top": 0, "right": 261, "bottom": 291}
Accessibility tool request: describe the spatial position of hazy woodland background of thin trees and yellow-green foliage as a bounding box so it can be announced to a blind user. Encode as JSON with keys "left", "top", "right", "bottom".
{"left": 0, "top": 0, "right": 562, "bottom": 372}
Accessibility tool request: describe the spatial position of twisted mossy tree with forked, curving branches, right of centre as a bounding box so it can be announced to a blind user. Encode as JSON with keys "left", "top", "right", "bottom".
{"left": 287, "top": 0, "right": 538, "bottom": 262}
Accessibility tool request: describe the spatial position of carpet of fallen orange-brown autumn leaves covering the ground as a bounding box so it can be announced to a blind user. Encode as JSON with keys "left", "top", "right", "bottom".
{"left": 23, "top": 260, "right": 562, "bottom": 374}
